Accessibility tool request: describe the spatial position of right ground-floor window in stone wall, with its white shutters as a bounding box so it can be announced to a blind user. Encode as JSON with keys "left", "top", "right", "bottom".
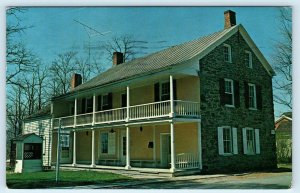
{"left": 243, "top": 128, "right": 260, "bottom": 155}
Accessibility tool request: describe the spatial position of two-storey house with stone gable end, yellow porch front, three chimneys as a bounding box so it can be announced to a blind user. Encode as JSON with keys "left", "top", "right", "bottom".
{"left": 52, "top": 10, "right": 276, "bottom": 175}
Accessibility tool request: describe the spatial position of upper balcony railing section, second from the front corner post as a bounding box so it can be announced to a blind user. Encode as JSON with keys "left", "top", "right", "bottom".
{"left": 95, "top": 107, "right": 127, "bottom": 123}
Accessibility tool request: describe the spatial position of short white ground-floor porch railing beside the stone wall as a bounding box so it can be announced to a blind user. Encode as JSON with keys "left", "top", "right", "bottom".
{"left": 175, "top": 153, "right": 199, "bottom": 169}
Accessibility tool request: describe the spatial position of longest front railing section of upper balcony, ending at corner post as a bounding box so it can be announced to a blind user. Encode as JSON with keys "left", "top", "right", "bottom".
{"left": 129, "top": 101, "right": 171, "bottom": 120}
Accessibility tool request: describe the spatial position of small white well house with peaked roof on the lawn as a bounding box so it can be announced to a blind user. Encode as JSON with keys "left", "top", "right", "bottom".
{"left": 14, "top": 133, "right": 43, "bottom": 173}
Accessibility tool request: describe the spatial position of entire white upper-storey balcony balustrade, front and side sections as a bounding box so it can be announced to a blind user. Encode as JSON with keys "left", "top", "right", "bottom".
{"left": 53, "top": 100, "right": 200, "bottom": 128}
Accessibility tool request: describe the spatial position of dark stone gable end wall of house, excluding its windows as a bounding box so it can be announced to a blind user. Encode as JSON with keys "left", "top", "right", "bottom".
{"left": 199, "top": 32, "right": 276, "bottom": 172}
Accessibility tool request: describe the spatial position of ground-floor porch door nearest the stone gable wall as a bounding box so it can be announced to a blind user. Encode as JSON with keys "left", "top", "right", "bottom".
{"left": 160, "top": 133, "right": 171, "bottom": 168}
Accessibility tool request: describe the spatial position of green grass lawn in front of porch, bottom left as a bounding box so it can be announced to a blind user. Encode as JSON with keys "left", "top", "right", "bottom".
{"left": 6, "top": 171, "right": 130, "bottom": 189}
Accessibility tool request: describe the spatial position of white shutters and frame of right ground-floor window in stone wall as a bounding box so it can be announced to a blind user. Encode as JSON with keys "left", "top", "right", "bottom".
{"left": 243, "top": 127, "right": 260, "bottom": 155}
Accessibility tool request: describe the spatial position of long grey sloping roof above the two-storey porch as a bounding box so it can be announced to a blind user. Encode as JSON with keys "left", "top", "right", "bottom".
{"left": 72, "top": 25, "right": 238, "bottom": 92}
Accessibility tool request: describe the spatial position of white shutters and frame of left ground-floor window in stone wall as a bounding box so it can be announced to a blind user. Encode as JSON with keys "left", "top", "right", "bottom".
{"left": 218, "top": 126, "right": 238, "bottom": 156}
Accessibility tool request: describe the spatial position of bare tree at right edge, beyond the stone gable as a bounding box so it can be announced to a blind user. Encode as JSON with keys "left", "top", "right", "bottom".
{"left": 273, "top": 8, "right": 292, "bottom": 110}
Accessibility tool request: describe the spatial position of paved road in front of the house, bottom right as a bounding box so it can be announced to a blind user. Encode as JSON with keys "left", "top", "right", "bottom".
{"left": 114, "top": 172, "right": 292, "bottom": 189}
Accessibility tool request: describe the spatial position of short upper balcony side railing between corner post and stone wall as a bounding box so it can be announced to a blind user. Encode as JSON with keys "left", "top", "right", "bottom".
{"left": 174, "top": 100, "right": 200, "bottom": 117}
